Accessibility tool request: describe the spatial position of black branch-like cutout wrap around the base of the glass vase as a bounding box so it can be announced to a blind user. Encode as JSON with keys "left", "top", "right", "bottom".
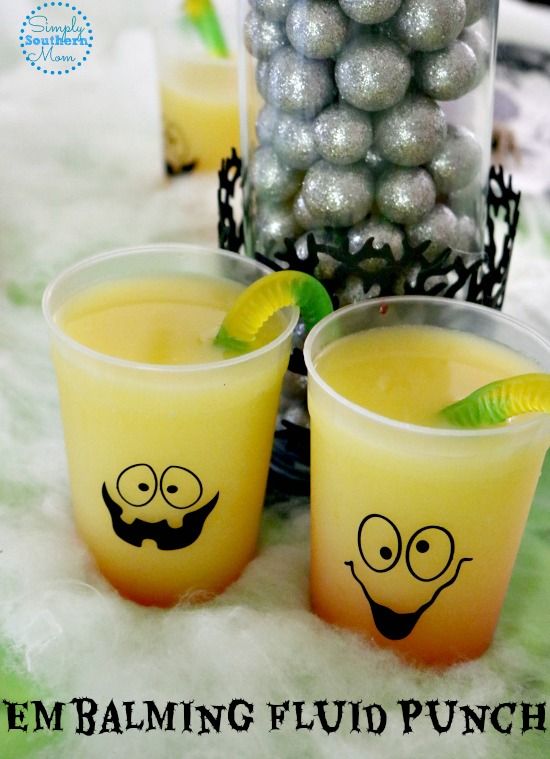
{"left": 218, "top": 150, "right": 520, "bottom": 497}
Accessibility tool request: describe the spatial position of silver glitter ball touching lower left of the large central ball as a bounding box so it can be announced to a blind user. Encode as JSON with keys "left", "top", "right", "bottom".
{"left": 313, "top": 103, "right": 373, "bottom": 165}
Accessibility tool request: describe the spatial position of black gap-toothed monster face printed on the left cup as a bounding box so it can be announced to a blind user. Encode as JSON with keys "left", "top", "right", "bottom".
{"left": 101, "top": 464, "right": 220, "bottom": 551}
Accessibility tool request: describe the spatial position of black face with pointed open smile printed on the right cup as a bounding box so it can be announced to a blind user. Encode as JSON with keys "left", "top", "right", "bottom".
{"left": 345, "top": 514, "right": 472, "bottom": 640}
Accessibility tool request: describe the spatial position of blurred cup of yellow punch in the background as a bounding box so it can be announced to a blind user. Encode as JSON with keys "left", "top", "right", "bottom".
{"left": 161, "top": 60, "right": 240, "bottom": 171}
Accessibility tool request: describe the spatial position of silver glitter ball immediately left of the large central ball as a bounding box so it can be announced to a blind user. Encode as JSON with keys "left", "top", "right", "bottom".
{"left": 267, "top": 47, "right": 335, "bottom": 118}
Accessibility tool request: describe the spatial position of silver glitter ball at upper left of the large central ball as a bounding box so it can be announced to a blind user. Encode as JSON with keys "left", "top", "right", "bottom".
{"left": 286, "top": 0, "right": 349, "bottom": 58}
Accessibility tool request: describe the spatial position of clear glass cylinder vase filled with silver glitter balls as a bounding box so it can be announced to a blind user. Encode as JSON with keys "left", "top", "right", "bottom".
{"left": 240, "top": 0, "right": 498, "bottom": 305}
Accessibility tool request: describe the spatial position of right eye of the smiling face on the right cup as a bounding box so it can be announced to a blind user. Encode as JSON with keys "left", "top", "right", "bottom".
{"left": 405, "top": 525, "right": 455, "bottom": 582}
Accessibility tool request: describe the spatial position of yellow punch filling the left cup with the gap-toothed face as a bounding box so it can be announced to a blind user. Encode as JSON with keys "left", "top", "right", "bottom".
{"left": 54, "top": 277, "right": 289, "bottom": 605}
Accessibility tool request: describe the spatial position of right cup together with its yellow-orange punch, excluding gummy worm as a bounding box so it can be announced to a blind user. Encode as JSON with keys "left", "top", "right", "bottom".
{"left": 305, "top": 297, "right": 550, "bottom": 665}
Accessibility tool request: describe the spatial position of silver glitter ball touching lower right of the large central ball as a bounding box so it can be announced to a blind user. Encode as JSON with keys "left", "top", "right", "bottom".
{"left": 374, "top": 95, "right": 447, "bottom": 166}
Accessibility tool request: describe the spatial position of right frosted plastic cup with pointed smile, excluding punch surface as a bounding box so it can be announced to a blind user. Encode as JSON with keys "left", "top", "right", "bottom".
{"left": 304, "top": 297, "right": 550, "bottom": 665}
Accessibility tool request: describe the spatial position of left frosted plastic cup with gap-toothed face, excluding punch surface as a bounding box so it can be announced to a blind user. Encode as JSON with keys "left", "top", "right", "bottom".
{"left": 43, "top": 245, "right": 297, "bottom": 606}
